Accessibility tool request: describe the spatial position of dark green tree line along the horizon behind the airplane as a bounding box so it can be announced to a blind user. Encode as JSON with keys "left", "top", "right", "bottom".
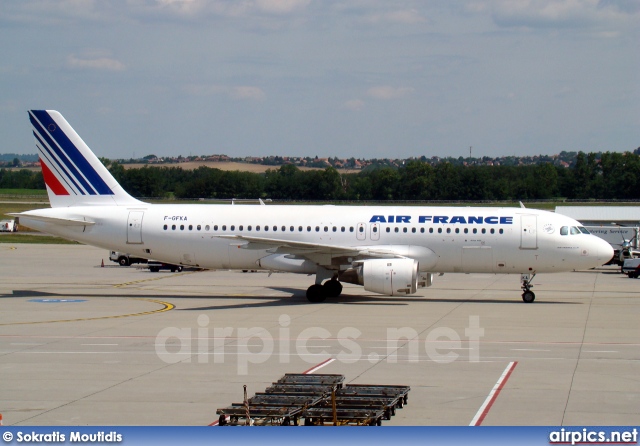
{"left": 0, "top": 152, "right": 640, "bottom": 201}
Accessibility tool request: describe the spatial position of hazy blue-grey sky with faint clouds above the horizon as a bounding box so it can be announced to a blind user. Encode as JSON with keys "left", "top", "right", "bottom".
{"left": 0, "top": 0, "right": 640, "bottom": 159}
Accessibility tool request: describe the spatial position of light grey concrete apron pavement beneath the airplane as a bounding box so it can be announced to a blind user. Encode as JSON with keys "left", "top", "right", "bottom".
{"left": 0, "top": 244, "right": 640, "bottom": 426}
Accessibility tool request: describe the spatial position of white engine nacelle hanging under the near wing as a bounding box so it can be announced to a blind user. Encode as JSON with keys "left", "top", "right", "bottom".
{"left": 340, "top": 259, "right": 419, "bottom": 296}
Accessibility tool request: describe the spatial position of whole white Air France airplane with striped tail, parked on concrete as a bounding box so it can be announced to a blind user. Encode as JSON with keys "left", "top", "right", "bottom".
{"left": 12, "top": 110, "right": 613, "bottom": 303}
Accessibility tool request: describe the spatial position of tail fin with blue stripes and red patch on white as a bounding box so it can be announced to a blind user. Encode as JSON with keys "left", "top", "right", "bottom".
{"left": 29, "top": 110, "right": 142, "bottom": 207}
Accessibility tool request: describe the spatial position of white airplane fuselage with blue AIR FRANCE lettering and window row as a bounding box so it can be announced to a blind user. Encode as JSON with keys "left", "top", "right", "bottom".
{"left": 20, "top": 203, "right": 611, "bottom": 274}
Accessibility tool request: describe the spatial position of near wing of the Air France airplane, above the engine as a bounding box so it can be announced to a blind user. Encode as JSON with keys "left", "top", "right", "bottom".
{"left": 217, "top": 235, "right": 405, "bottom": 258}
